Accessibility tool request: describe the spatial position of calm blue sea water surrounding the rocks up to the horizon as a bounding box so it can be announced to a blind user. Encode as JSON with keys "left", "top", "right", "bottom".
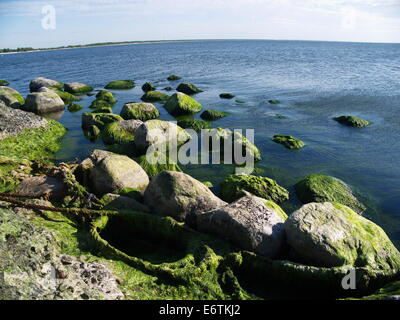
{"left": 0, "top": 41, "right": 400, "bottom": 244}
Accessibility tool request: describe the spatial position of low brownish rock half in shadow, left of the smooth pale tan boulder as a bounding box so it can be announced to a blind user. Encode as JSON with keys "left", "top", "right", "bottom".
{"left": 16, "top": 176, "right": 68, "bottom": 200}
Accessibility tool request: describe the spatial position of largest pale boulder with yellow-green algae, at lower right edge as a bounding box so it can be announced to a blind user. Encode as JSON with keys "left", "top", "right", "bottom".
{"left": 285, "top": 202, "right": 400, "bottom": 271}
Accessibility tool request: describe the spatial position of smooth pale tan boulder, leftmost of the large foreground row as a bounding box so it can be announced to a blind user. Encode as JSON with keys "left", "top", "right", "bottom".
{"left": 78, "top": 150, "right": 149, "bottom": 196}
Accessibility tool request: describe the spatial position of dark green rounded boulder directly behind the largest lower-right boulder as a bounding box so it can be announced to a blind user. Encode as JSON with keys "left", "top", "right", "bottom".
{"left": 295, "top": 174, "right": 365, "bottom": 213}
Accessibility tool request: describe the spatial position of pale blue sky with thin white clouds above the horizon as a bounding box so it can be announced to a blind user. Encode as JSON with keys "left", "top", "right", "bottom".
{"left": 0, "top": 0, "right": 400, "bottom": 48}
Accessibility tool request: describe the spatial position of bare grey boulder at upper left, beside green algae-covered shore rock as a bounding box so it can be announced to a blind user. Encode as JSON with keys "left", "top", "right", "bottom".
{"left": 21, "top": 92, "right": 65, "bottom": 114}
